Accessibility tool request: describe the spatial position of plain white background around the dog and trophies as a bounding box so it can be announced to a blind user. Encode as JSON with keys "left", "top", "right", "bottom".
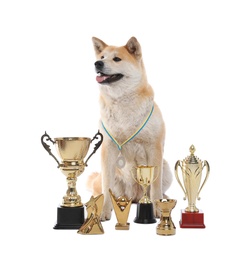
{"left": 0, "top": 0, "right": 250, "bottom": 259}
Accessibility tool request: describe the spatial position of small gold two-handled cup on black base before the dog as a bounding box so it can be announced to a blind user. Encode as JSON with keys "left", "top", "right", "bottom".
{"left": 132, "top": 165, "right": 158, "bottom": 224}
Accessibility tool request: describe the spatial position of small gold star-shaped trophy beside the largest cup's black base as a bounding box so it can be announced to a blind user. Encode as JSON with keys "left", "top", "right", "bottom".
{"left": 77, "top": 194, "right": 104, "bottom": 235}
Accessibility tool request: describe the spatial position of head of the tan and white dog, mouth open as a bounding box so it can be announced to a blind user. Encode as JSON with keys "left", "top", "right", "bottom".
{"left": 92, "top": 37, "right": 146, "bottom": 96}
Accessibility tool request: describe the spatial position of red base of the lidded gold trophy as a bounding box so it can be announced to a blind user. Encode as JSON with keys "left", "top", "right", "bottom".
{"left": 180, "top": 209, "right": 206, "bottom": 228}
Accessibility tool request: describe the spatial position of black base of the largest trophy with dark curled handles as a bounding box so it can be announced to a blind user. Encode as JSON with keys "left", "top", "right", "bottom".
{"left": 54, "top": 206, "right": 84, "bottom": 229}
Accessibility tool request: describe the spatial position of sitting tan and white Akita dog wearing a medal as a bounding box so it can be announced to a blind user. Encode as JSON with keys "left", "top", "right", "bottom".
{"left": 87, "top": 37, "right": 172, "bottom": 221}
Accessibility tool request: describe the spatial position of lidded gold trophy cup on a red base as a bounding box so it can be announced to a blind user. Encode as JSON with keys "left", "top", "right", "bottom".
{"left": 175, "top": 145, "right": 210, "bottom": 228}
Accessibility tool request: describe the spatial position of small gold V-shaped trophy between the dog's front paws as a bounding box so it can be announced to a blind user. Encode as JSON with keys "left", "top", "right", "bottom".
{"left": 109, "top": 189, "right": 132, "bottom": 230}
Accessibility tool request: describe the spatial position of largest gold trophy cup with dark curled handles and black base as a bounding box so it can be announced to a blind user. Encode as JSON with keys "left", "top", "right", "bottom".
{"left": 41, "top": 131, "right": 103, "bottom": 229}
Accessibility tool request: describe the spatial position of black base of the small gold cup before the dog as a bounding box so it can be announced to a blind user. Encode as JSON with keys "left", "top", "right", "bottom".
{"left": 134, "top": 203, "right": 156, "bottom": 224}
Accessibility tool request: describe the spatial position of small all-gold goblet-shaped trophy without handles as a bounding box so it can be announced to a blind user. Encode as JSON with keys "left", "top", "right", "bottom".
{"left": 155, "top": 199, "right": 177, "bottom": 236}
